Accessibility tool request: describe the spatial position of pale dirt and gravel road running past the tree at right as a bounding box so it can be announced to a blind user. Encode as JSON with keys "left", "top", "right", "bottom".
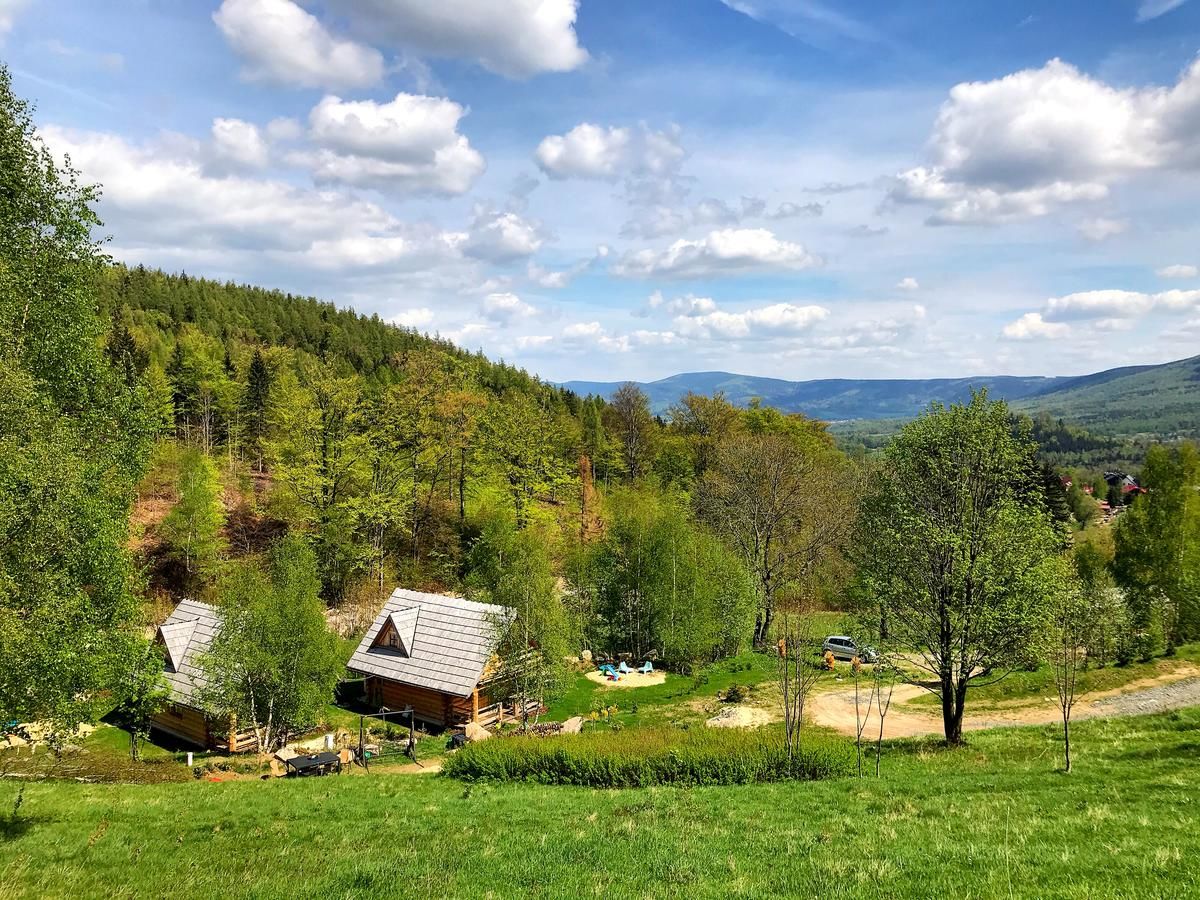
{"left": 806, "top": 666, "right": 1200, "bottom": 738}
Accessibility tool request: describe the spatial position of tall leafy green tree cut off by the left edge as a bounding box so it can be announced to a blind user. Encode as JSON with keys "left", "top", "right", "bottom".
{"left": 0, "top": 66, "right": 149, "bottom": 726}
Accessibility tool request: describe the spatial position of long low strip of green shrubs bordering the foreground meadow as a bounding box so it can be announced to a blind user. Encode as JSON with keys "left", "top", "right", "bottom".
{"left": 443, "top": 727, "right": 853, "bottom": 787}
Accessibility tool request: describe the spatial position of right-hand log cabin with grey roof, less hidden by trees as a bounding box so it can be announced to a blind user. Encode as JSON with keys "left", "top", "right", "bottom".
{"left": 348, "top": 588, "right": 532, "bottom": 727}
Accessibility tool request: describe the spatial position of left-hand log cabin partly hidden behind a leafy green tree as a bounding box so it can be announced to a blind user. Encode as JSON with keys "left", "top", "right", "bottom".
{"left": 151, "top": 600, "right": 258, "bottom": 754}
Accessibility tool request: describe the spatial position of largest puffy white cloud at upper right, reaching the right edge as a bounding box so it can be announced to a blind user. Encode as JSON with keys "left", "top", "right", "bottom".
{"left": 890, "top": 59, "right": 1200, "bottom": 224}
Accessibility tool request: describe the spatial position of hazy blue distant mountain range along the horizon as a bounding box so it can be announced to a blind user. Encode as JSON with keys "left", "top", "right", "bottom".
{"left": 563, "top": 356, "right": 1200, "bottom": 434}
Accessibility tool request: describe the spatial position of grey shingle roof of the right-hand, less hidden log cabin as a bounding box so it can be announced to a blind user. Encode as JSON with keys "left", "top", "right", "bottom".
{"left": 348, "top": 588, "right": 514, "bottom": 697}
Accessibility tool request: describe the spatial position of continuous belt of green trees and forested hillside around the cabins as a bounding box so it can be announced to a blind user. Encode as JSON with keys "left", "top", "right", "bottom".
{"left": 0, "top": 66, "right": 1200, "bottom": 740}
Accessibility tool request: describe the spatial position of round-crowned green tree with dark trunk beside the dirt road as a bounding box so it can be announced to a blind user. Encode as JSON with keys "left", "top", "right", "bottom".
{"left": 854, "top": 392, "right": 1062, "bottom": 744}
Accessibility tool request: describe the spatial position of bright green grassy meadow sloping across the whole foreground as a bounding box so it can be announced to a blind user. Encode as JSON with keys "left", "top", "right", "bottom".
{"left": 0, "top": 709, "right": 1200, "bottom": 899}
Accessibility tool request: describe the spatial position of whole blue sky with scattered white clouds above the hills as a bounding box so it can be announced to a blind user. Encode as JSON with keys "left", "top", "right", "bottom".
{"left": 7, "top": 0, "right": 1200, "bottom": 380}
